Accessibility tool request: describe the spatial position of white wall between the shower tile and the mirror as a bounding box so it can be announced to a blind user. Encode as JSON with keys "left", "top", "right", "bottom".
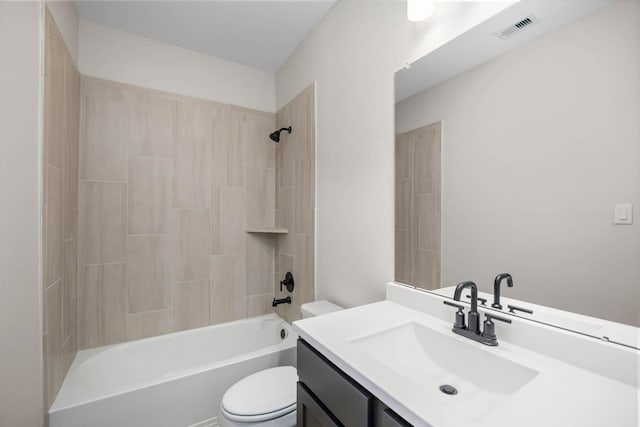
{"left": 276, "top": 0, "right": 507, "bottom": 306}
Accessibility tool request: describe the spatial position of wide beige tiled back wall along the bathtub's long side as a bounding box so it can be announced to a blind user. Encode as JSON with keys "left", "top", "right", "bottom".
{"left": 78, "top": 77, "right": 276, "bottom": 348}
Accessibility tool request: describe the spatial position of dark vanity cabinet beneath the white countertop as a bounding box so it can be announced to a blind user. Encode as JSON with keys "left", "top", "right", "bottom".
{"left": 297, "top": 339, "right": 411, "bottom": 427}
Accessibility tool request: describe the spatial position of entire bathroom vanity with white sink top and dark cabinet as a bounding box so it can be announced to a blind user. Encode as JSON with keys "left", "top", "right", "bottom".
{"left": 294, "top": 283, "right": 640, "bottom": 427}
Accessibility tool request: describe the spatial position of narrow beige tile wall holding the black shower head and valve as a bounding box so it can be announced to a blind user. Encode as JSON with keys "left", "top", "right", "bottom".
{"left": 276, "top": 84, "right": 316, "bottom": 322}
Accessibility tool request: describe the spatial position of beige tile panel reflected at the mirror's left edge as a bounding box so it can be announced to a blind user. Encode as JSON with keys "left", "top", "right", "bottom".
{"left": 395, "top": 122, "right": 441, "bottom": 289}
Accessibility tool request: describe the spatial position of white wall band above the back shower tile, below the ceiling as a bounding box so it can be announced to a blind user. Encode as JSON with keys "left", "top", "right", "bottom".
{"left": 79, "top": 19, "right": 276, "bottom": 113}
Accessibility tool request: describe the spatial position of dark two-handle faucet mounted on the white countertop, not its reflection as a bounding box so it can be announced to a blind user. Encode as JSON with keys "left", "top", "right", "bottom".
{"left": 444, "top": 282, "right": 511, "bottom": 346}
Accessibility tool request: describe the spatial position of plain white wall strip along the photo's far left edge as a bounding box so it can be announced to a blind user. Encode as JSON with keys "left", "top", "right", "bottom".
{"left": 0, "top": 1, "right": 44, "bottom": 427}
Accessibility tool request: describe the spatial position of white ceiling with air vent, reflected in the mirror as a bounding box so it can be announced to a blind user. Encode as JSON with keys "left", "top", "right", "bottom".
{"left": 395, "top": 0, "right": 614, "bottom": 102}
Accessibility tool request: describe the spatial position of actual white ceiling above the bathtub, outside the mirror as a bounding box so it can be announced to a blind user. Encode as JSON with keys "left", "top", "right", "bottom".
{"left": 76, "top": 0, "right": 336, "bottom": 72}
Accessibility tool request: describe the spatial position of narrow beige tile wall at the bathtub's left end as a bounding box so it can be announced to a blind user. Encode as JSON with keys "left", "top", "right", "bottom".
{"left": 42, "top": 9, "right": 80, "bottom": 406}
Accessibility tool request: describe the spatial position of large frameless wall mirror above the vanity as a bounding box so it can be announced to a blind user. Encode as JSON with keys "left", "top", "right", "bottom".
{"left": 395, "top": 0, "right": 640, "bottom": 347}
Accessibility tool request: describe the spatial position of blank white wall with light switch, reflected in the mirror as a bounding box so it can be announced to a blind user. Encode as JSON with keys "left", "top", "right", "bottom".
{"left": 396, "top": 0, "right": 640, "bottom": 323}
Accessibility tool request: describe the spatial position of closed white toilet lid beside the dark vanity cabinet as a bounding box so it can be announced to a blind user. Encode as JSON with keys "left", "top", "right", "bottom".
{"left": 221, "top": 366, "right": 298, "bottom": 419}
